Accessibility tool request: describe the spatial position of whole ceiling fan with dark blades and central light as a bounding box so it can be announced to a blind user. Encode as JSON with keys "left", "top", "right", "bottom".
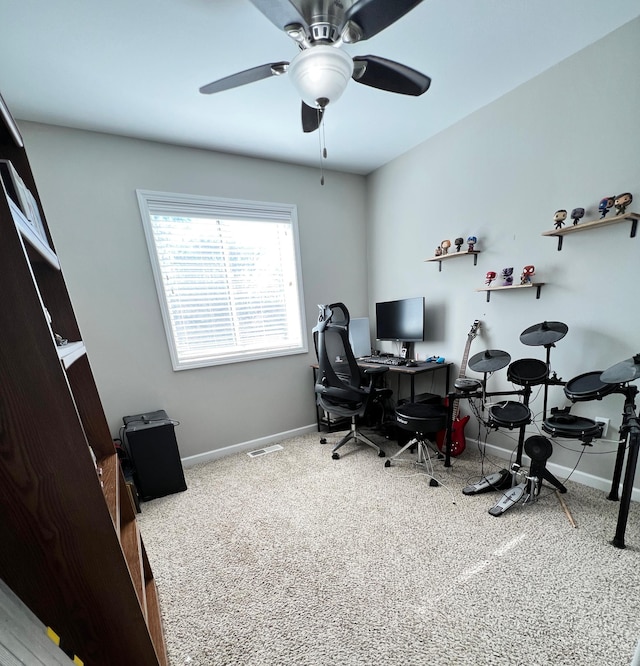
{"left": 200, "top": 0, "right": 431, "bottom": 132}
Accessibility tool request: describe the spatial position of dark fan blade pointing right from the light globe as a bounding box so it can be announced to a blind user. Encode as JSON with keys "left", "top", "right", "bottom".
{"left": 352, "top": 56, "right": 431, "bottom": 97}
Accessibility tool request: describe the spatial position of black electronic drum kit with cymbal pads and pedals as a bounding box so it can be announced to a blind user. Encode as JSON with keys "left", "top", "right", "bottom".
{"left": 449, "top": 321, "right": 640, "bottom": 548}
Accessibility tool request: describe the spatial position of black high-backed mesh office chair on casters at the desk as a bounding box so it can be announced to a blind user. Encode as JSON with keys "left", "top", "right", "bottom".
{"left": 313, "top": 303, "right": 392, "bottom": 460}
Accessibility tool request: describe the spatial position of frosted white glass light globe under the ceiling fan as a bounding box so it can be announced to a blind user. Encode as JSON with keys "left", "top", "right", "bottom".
{"left": 288, "top": 44, "right": 353, "bottom": 108}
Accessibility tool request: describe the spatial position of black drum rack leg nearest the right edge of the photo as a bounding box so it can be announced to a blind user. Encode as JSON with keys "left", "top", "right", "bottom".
{"left": 607, "top": 385, "right": 640, "bottom": 548}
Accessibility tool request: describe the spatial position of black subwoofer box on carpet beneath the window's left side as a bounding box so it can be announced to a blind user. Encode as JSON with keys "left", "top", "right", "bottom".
{"left": 122, "top": 409, "right": 187, "bottom": 500}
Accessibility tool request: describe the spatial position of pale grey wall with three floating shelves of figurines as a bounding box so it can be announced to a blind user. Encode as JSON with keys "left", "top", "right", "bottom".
{"left": 367, "top": 19, "right": 640, "bottom": 483}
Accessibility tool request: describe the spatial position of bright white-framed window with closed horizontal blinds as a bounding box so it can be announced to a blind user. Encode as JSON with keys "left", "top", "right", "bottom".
{"left": 137, "top": 190, "right": 307, "bottom": 370}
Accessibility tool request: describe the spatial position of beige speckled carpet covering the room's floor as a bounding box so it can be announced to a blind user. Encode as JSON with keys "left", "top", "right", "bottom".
{"left": 140, "top": 433, "right": 640, "bottom": 666}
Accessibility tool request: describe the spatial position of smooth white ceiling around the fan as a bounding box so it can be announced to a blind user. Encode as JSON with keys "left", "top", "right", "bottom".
{"left": 0, "top": 0, "right": 640, "bottom": 174}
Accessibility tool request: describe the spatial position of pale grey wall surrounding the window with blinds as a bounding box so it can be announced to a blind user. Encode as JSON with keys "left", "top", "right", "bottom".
{"left": 20, "top": 123, "right": 367, "bottom": 457}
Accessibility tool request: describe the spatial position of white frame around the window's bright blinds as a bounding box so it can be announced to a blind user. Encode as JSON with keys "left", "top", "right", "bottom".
{"left": 136, "top": 190, "right": 308, "bottom": 370}
